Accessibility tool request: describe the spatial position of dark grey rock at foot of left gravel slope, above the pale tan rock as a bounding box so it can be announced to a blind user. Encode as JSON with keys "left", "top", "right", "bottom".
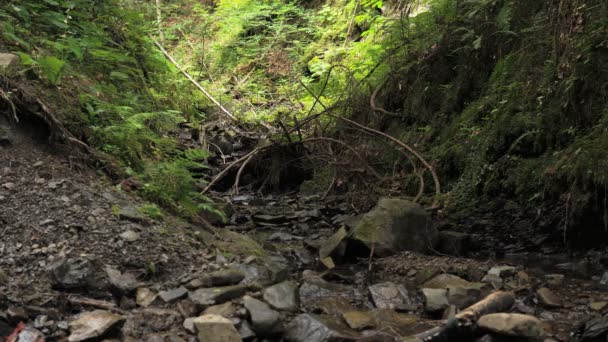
{"left": 49, "top": 257, "right": 106, "bottom": 290}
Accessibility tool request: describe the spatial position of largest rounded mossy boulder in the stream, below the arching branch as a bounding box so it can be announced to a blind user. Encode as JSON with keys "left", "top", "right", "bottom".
{"left": 352, "top": 198, "right": 439, "bottom": 255}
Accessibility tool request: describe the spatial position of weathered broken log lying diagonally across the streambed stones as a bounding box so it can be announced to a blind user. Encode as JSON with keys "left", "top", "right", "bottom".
{"left": 406, "top": 291, "right": 515, "bottom": 342}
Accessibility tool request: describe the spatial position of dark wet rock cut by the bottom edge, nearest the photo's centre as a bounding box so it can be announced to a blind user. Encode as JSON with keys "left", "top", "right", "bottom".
{"left": 284, "top": 314, "right": 360, "bottom": 342}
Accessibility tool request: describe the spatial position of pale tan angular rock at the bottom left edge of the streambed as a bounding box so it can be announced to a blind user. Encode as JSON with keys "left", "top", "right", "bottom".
{"left": 68, "top": 310, "right": 125, "bottom": 342}
